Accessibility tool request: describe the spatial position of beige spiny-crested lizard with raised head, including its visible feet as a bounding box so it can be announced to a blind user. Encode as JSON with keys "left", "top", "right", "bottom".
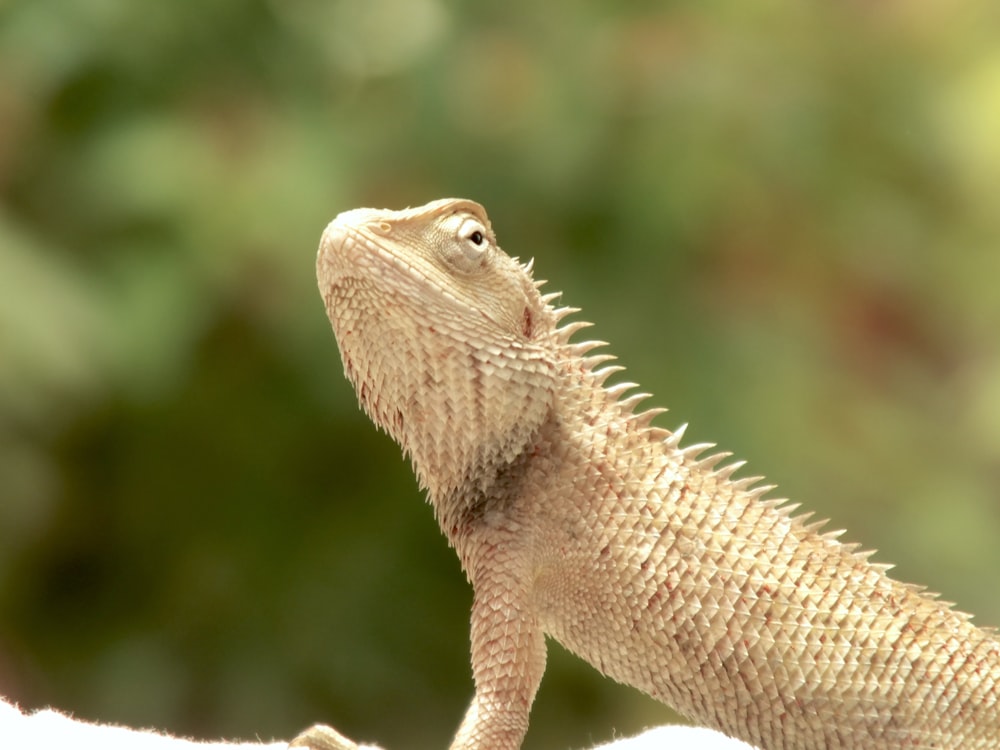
{"left": 295, "top": 199, "right": 1000, "bottom": 750}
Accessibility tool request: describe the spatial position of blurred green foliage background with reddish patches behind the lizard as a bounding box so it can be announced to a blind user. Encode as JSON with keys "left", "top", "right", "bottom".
{"left": 0, "top": 0, "right": 1000, "bottom": 748}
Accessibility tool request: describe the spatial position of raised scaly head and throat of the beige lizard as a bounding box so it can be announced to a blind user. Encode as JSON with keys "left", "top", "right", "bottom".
{"left": 317, "top": 199, "right": 556, "bottom": 501}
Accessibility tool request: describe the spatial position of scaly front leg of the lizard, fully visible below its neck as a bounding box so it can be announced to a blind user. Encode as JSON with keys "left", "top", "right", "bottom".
{"left": 451, "top": 543, "right": 545, "bottom": 750}
